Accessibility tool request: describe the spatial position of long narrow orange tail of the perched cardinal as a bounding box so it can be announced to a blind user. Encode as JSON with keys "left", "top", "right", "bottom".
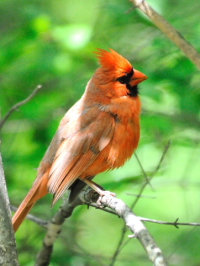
{"left": 12, "top": 174, "right": 48, "bottom": 232}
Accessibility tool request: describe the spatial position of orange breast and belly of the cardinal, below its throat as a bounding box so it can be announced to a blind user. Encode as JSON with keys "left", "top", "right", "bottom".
{"left": 81, "top": 96, "right": 140, "bottom": 176}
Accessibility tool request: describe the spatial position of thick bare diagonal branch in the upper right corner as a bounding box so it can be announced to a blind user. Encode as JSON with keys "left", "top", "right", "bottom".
{"left": 129, "top": 0, "right": 200, "bottom": 69}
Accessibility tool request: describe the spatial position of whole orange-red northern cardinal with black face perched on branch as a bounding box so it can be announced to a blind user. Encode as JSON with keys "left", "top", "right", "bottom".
{"left": 13, "top": 49, "right": 147, "bottom": 231}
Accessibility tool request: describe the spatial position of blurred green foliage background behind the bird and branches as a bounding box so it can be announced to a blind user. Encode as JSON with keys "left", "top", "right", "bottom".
{"left": 0, "top": 0, "right": 200, "bottom": 266}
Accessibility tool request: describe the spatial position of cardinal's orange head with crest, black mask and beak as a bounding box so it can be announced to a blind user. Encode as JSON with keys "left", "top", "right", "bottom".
{"left": 95, "top": 49, "right": 148, "bottom": 97}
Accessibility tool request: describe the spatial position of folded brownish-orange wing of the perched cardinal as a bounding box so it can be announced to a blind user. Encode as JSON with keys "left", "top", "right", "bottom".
{"left": 48, "top": 107, "right": 115, "bottom": 204}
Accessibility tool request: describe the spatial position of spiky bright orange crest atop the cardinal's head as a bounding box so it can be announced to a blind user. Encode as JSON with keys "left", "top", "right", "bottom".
{"left": 95, "top": 49, "right": 133, "bottom": 73}
